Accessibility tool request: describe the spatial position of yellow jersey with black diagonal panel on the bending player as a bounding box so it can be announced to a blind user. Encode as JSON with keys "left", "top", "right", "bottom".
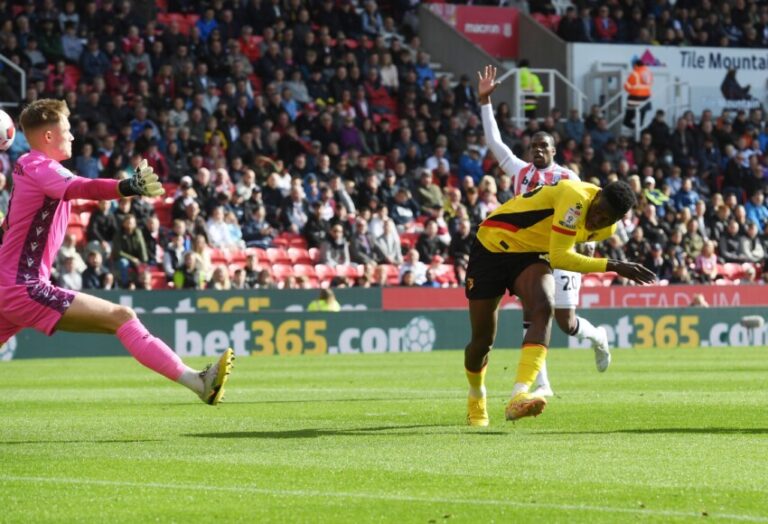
{"left": 477, "top": 180, "right": 616, "bottom": 273}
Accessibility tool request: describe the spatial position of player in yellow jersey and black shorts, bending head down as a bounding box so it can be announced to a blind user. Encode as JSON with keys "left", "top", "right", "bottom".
{"left": 464, "top": 180, "right": 655, "bottom": 426}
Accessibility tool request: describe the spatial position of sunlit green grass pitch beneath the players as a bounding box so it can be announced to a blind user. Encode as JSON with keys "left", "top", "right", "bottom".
{"left": 0, "top": 348, "right": 768, "bottom": 523}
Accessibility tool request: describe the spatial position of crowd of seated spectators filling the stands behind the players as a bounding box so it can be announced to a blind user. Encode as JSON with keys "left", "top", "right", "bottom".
{"left": 0, "top": 0, "right": 768, "bottom": 289}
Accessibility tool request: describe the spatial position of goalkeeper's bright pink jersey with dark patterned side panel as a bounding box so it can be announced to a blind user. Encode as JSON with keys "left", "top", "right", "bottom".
{"left": 0, "top": 150, "right": 75, "bottom": 286}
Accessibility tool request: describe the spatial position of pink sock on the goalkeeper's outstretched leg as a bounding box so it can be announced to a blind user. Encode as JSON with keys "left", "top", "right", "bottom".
{"left": 116, "top": 318, "right": 193, "bottom": 382}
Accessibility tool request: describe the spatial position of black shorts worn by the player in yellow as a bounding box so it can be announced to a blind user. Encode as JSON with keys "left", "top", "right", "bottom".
{"left": 464, "top": 239, "right": 549, "bottom": 300}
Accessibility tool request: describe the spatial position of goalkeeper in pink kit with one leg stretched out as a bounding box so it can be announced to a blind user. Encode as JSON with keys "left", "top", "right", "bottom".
{"left": 0, "top": 99, "right": 234, "bottom": 405}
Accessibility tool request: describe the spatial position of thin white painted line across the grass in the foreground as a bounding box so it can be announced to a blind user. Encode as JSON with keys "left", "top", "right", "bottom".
{"left": 0, "top": 475, "right": 768, "bottom": 522}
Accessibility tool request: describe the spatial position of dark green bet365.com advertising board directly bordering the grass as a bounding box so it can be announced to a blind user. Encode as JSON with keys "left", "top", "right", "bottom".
{"left": 0, "top": 307, "right": 768, "bottom": 360}
